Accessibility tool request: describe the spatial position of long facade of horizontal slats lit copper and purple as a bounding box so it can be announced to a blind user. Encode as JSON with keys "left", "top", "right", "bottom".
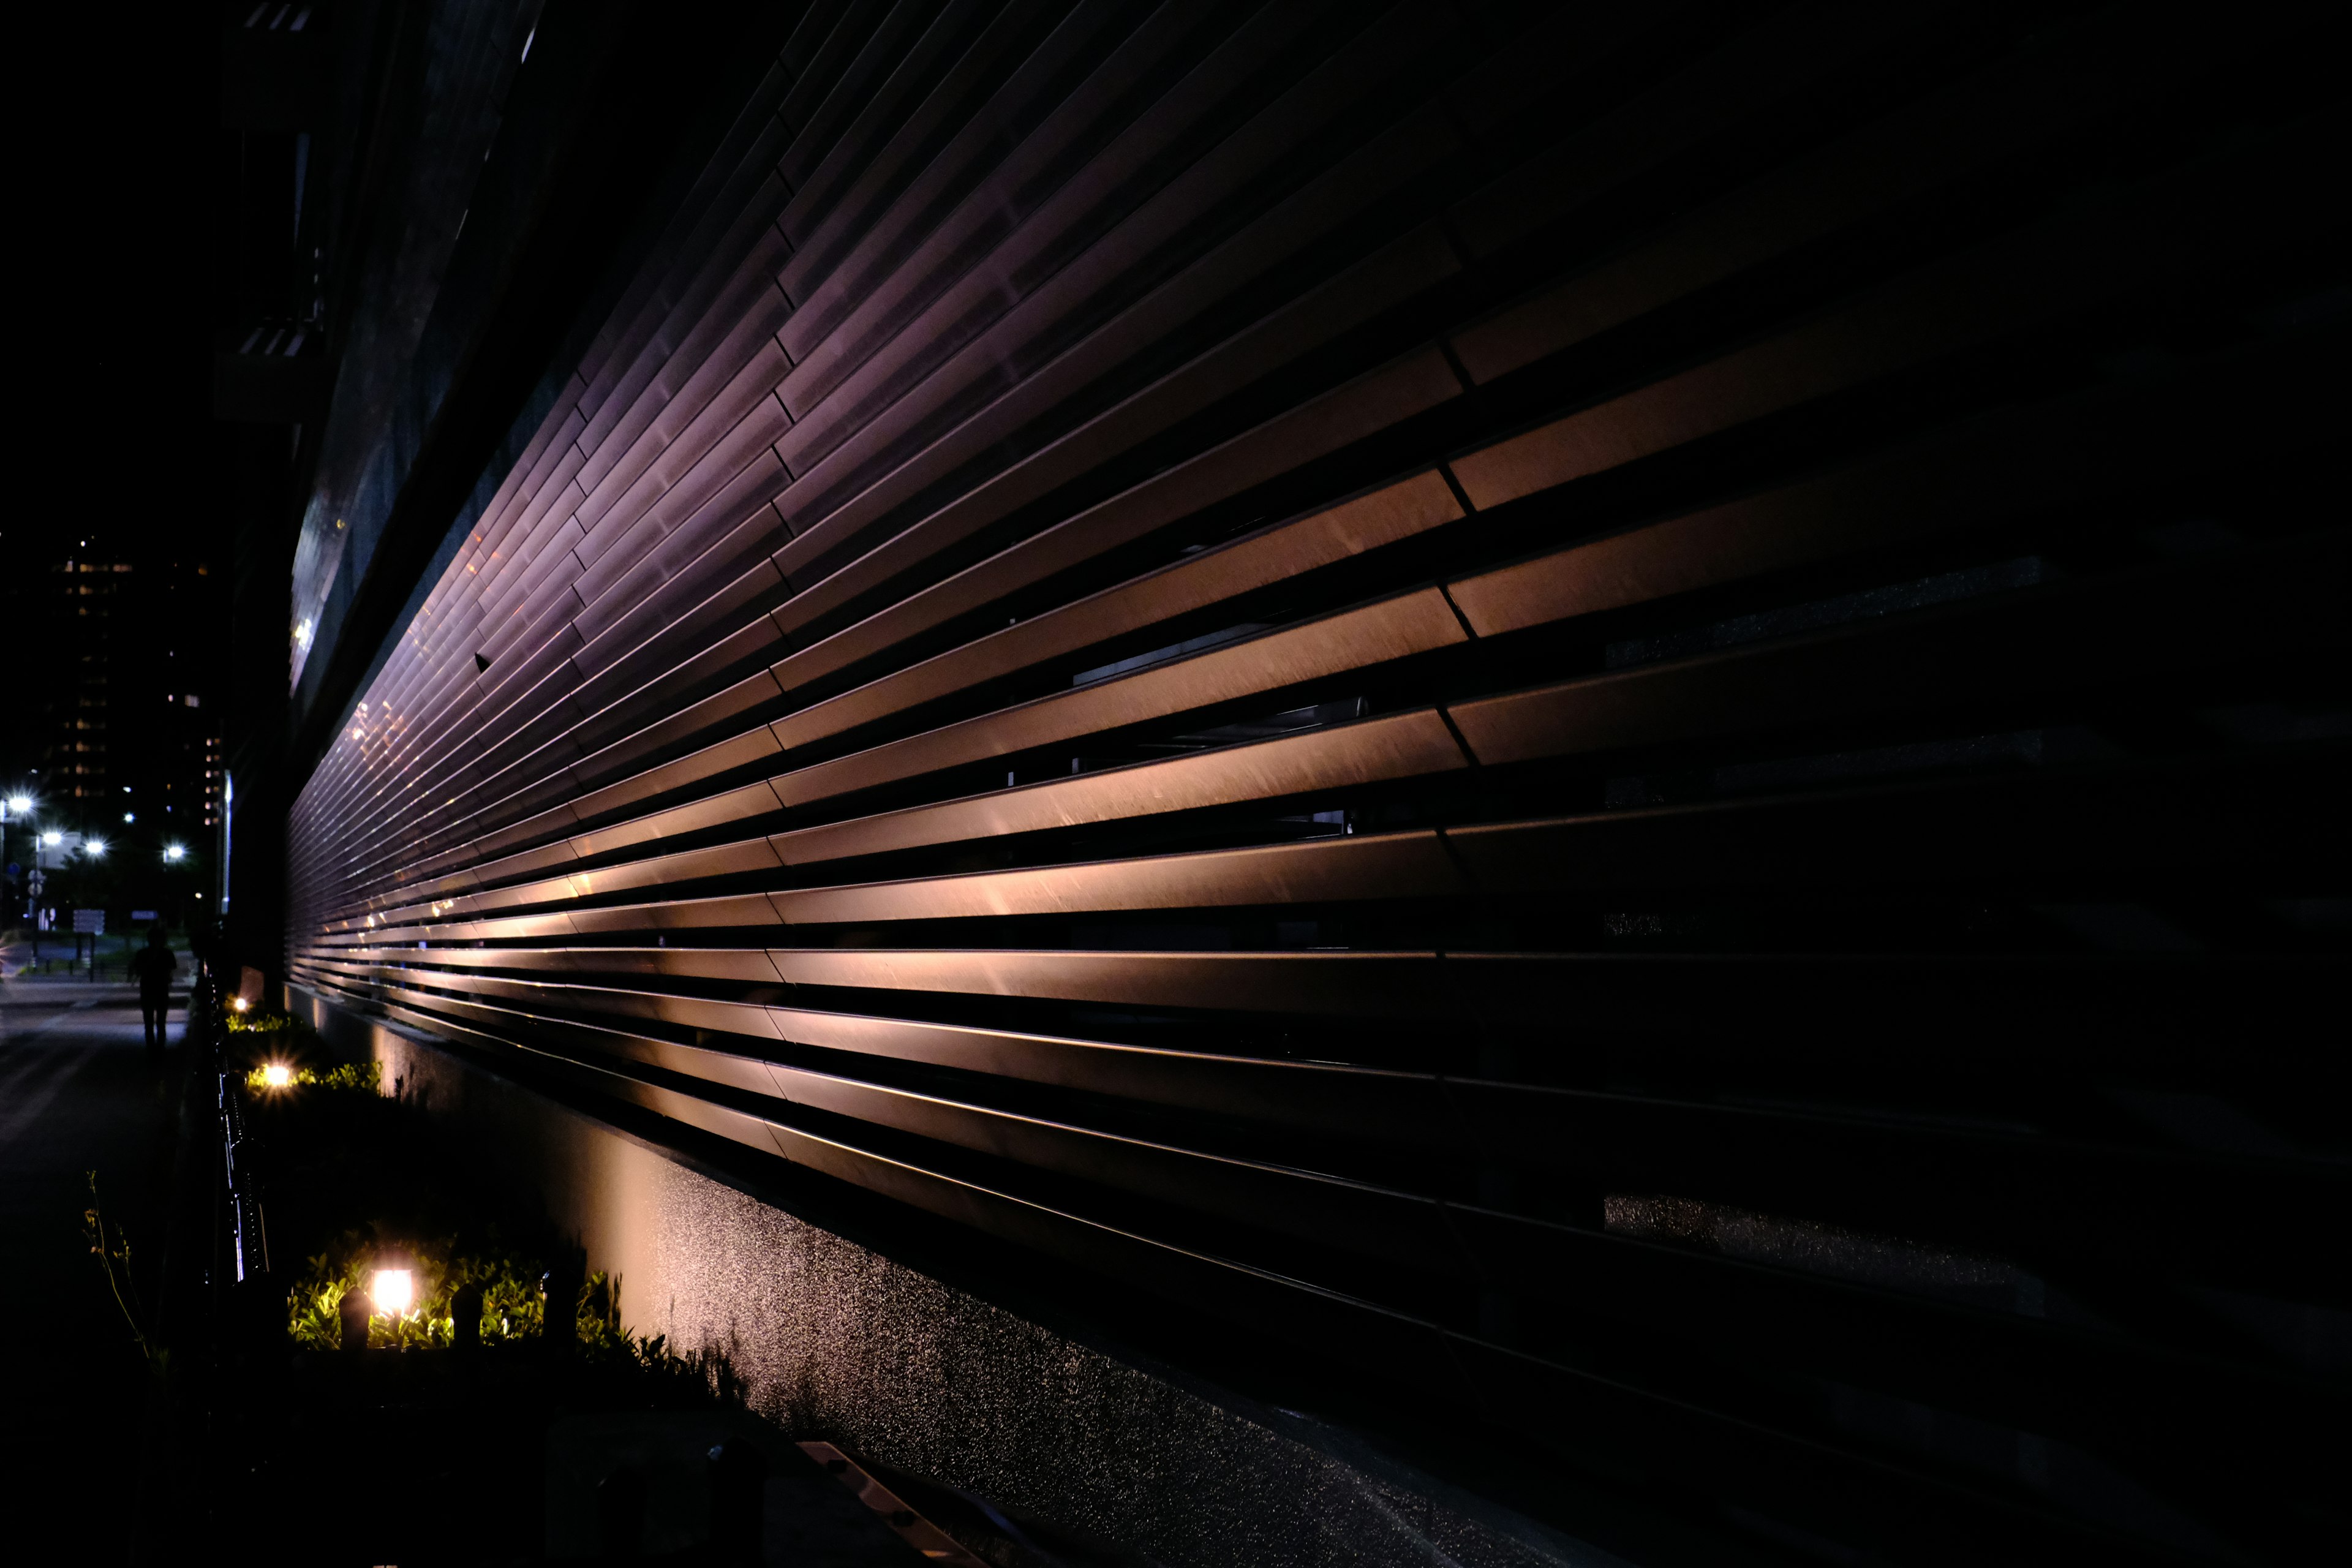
{"left": 289, "top": 0, "right": 2352, "bottom": 1561}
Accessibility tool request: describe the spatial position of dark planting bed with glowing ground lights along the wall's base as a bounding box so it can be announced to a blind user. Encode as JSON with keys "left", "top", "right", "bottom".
{"left": 209, "top": 1013, "right": 964, "bottom": 1568}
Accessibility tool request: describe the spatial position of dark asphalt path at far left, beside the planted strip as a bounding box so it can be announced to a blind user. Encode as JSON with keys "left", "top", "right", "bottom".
{"left": 0, "top": 980, "right": 184, "bottom": 1563}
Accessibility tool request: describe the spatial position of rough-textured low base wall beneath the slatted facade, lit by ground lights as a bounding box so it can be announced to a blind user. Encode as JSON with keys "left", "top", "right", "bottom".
{"left": 289, "top": 992, "right": 1618, "bottom": 1568}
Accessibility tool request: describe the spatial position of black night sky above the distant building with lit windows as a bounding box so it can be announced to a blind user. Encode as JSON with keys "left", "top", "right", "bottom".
{"left": 0, "top": 5, "right": 235, "bottom": 776}
